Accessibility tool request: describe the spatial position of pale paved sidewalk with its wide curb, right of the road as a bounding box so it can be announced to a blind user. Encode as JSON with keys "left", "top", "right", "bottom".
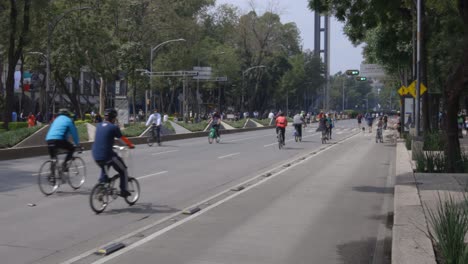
{"left": 392, "top": 140, "right": 468, "bottom": 264}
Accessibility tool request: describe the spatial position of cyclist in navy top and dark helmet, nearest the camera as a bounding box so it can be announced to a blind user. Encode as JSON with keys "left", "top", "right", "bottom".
{"left": 92, "top": 108, "right": 135, "bottom": 197}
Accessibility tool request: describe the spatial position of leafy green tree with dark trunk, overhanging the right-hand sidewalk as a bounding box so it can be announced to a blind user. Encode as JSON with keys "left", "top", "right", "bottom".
{"left": 309, "top": 0, "right": 468, "bottom": 172}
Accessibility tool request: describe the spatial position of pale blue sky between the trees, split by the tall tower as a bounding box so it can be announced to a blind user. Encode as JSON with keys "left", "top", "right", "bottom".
{"left": 216, "top": 0, "right": 363, "bottom": 75}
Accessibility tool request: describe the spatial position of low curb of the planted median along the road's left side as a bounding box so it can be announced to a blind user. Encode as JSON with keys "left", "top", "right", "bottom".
{"left": 0, "top": 126, "right": 274, "bottom": 161}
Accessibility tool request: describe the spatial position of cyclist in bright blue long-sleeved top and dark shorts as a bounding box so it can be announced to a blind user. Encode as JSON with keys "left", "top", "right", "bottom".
{"left": 46, "top": 108, "right": 80, "bottom": 171}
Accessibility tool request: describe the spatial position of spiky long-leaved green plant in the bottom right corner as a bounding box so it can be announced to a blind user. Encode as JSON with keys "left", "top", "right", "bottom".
{"left": 426, "top": 194, "right": 468, "bottom": 264}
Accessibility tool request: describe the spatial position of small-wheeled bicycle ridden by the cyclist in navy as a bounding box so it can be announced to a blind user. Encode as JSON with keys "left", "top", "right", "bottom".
{"left": 89, "top": 146, "right": 140, "bottom": 214}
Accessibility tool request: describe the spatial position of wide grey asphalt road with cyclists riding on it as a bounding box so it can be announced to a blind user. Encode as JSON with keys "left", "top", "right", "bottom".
{"left": 0, "top": 120, "right": 395, "bottom": 264}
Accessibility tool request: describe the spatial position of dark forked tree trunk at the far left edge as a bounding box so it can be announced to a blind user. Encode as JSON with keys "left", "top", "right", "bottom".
{"left": 3, "top": 0, "right": 31, "bottom": 130}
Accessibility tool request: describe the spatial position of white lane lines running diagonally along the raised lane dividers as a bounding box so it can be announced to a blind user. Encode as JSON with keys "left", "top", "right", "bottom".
{"left": 90, "top": 134, "right": 357, "bottom": 264}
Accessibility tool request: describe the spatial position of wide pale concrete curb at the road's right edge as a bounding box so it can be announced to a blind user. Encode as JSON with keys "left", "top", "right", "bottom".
{"left": 392, "top": 142, "right": 436, "bottom": 264}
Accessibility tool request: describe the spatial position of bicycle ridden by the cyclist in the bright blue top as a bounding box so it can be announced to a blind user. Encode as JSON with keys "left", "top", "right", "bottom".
{"left": 37, "top": 148, "right": 86, "bottom": 195}
